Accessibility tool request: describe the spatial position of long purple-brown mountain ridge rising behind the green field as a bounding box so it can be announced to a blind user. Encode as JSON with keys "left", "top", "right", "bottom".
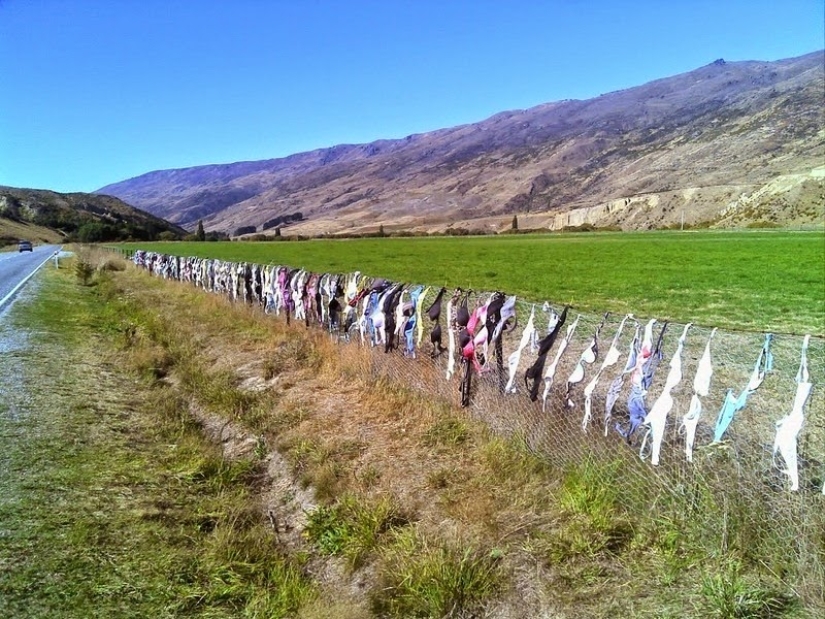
{"left": 99, "top": 51, "right": 825, "bottom": 234}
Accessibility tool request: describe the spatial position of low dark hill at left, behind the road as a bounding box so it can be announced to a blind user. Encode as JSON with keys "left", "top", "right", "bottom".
{"left": 0, "top": 186, "right": 186, "bottom": 244}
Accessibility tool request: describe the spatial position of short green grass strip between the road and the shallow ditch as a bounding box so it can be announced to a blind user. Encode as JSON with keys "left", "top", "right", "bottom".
{"left": 0, "top": 258, "right": 314, "bottom": 617}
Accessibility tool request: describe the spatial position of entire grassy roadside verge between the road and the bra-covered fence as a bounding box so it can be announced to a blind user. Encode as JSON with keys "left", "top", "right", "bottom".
{"left": 0, "top": 253, "right": 825, "bottom": 619}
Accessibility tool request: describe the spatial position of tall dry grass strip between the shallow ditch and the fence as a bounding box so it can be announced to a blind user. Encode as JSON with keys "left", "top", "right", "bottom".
{"left": 80, "top": 248, "right": 825, "bottom": 617}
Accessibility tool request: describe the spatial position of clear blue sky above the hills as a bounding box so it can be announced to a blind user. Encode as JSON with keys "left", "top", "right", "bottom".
{"left": 0, "top": 0, "right": 825, "bottom": 192}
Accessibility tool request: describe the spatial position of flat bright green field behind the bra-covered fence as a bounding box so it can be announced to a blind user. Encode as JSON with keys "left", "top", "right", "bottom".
{"left": 122, "top": 230, "right": 825, "bottom": 336}
